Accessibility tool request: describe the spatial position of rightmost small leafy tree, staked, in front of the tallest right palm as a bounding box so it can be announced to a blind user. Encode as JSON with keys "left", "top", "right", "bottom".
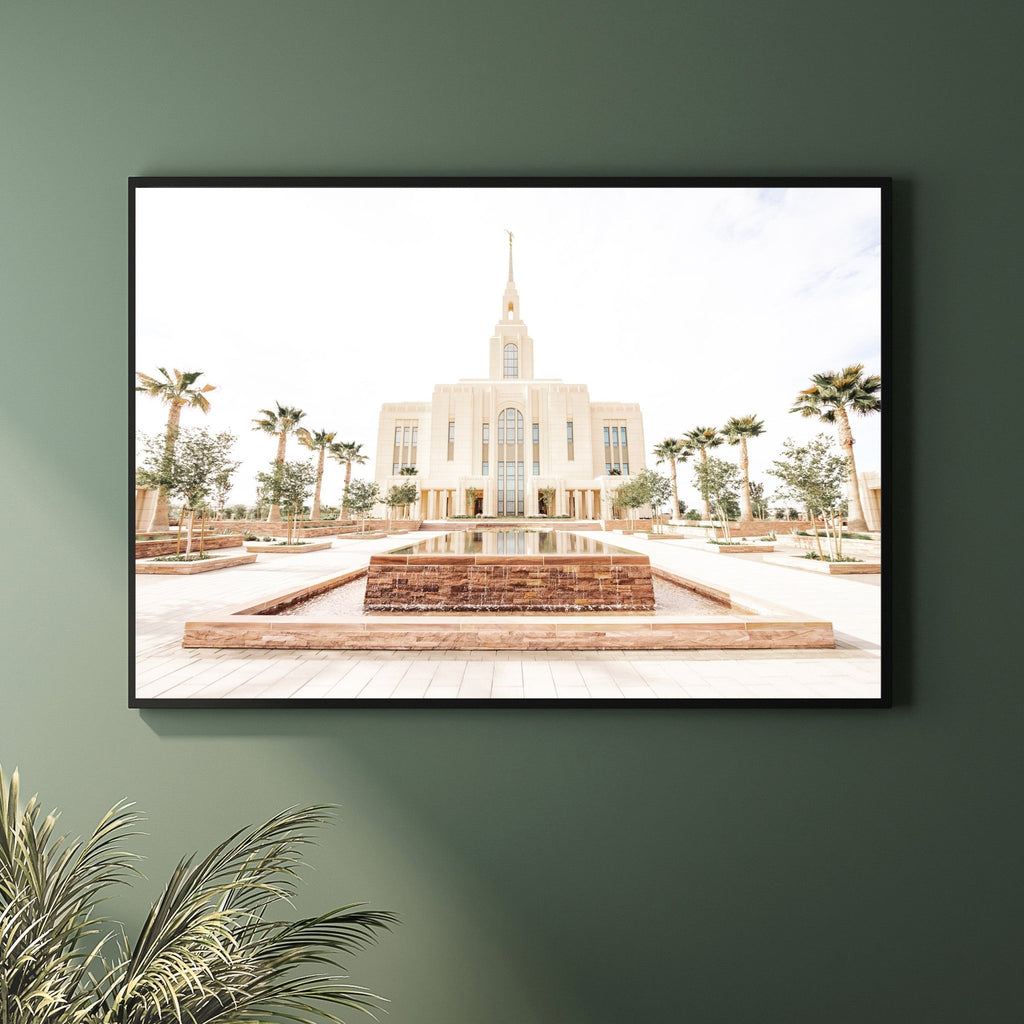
{"left": 768, "top": 434, "right": 850, "bottom": 559}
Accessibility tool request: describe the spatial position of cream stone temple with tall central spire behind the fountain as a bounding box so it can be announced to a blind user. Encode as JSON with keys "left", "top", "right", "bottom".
{"left": 376, "top": 232, "right": 645, "bottom": 519}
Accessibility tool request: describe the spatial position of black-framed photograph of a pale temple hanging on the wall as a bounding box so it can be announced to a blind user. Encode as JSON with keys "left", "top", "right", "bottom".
{"left": 129, "top": 177, "right": 892, "bottom": 708}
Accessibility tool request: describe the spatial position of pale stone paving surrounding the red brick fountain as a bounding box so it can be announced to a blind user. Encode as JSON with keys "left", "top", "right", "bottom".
{"left": 135, "top": 534, "right": 881, "bottom": 699}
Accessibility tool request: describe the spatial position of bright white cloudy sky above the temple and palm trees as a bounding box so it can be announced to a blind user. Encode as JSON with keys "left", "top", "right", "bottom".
{"left": 136, "top": 187, "right": 882, "bottom": 507}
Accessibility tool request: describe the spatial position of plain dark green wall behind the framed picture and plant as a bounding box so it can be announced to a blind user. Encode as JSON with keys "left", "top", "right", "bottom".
{"left": 0, "top": 0, "right": 1024, "bottom": 1024}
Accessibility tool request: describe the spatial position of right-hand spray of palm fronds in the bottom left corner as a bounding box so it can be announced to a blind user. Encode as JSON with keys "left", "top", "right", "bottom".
{"left": 110, "top": 806, "right": 396, "bottom": 1024}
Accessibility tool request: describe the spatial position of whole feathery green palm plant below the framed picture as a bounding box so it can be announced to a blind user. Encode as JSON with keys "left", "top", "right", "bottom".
{"left": 0, "top": 771, "right": 396, "bottom": 1024}
